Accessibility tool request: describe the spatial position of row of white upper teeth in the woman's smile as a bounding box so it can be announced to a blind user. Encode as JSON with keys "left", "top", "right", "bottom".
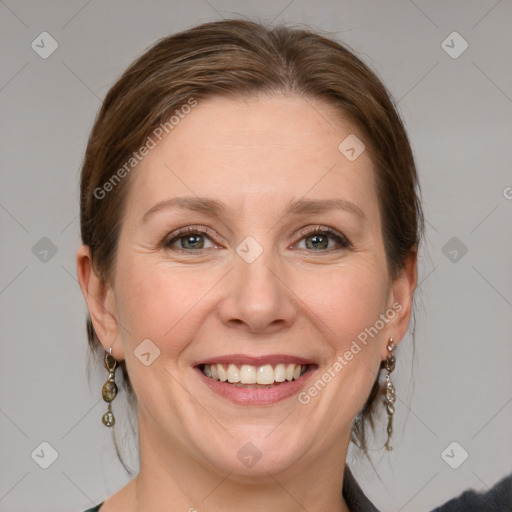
{"left": 203, "top": 363, "right": 306, "bottom": 384}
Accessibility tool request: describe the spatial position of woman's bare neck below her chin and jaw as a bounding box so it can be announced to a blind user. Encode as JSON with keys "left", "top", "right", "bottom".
{"left": 130, "top": 416, "right": 350, "bottom": 512}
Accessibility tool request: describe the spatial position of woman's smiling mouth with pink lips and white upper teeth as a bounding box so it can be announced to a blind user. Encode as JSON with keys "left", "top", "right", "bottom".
{"left": 194, "top": 354, "right": 318, "bottom": 405}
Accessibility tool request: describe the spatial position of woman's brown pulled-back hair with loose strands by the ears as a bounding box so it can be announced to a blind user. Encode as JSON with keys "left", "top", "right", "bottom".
{"left": 80, "top": 19, "right": 423, "bottom": 467}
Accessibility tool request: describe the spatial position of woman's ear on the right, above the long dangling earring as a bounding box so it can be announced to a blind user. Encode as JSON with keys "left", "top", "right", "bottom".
{"left": 381, "top": 247, "right": 418, "bottom": 360}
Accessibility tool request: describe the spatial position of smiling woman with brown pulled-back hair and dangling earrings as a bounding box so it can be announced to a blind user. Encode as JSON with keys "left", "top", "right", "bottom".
{"left": 77, "top": 20, "right": 508, "bottom": 512}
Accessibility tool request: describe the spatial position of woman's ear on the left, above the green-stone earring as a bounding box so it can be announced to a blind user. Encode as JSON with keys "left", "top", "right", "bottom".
{"left": 76, "top": 245, "right": 124, "bottom": 361}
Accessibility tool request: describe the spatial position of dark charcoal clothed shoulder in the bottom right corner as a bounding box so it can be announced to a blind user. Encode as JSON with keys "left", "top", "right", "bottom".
{"left": 432, "top": 474, "right": 512, "bottom": 512}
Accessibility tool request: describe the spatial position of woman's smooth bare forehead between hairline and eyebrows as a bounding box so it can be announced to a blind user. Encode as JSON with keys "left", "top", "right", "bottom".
{"left": 124, "top": 95, "right": 378, "bottom": 222}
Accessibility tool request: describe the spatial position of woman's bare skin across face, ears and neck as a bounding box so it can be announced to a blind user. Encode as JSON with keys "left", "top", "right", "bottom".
{"left": 77, "top": 95, "right": 417, "bottom": 512}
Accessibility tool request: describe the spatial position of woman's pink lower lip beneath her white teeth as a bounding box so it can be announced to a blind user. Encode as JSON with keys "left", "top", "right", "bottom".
{"left": 194, "top": 367, "right": 315, "bottom": 405}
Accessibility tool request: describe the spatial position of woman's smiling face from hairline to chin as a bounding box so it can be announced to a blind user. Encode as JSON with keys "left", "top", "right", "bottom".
{"left": 81, "top": 96, "right": 411, "bottom": 476}
